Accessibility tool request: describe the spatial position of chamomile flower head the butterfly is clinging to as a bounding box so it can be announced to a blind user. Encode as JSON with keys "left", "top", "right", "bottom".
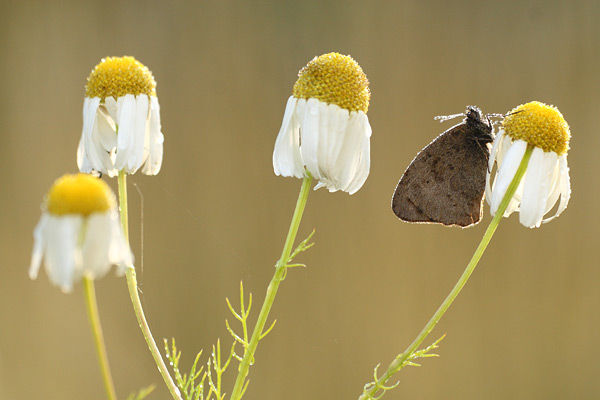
{"left": 486, "top": 101, "right": 571, "bottom": 228}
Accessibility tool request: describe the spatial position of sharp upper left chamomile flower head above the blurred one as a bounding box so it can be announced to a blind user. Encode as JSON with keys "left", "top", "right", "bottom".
{"left": 77, "top": 57, "right": 164, "bottom": 176}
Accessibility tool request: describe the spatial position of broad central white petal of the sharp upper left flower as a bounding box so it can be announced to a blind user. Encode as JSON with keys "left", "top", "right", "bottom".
{"left": 115, "top": 94, "right": 136, "bottom": 171}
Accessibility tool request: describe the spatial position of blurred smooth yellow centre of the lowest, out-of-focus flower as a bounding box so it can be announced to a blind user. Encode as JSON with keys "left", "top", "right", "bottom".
{"left": 46, "top": 174, "right": 116, "bottom": 216}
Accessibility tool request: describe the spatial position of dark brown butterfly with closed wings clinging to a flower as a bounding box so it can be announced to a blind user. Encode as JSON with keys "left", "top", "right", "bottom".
{"left": 392, "top": 106, "right": 494, "bottom": 227}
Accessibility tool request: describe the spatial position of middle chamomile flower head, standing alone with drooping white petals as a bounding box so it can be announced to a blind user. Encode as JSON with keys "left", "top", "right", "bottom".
{"left": 273, "top": 53, "right": 371, "bottom": 194}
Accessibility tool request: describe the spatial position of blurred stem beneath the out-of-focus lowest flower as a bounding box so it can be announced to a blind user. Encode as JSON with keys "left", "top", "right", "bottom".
{"left": 83, "top": 277, "right": 117, "bottom": 400}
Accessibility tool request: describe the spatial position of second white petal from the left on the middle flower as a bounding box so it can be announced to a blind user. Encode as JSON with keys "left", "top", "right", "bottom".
{"left": 298, "top": 99, "right": 322, "bottom": 181}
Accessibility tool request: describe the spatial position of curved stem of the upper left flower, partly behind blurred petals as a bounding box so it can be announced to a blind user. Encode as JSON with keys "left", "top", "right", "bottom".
{"left": 119, "top": 170, "right": 181, "bottom": 400}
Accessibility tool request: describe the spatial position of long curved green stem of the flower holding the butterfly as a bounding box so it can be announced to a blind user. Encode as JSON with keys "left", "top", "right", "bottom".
{"left": 359, "top": 146, "right": 533, "bottom": 399}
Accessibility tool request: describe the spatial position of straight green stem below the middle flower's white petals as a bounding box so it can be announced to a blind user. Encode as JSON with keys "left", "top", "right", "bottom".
{"left": 231, "top": 172, "right": 312, "bottom": 400}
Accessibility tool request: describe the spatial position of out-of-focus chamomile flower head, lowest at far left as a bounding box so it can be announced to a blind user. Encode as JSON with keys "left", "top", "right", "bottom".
{"left": 29, "top": 174, "right": 133, "bottom": 292}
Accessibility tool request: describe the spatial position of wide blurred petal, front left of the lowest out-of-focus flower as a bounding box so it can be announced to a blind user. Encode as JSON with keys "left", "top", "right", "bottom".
{"left": 44, "top": 215, "right": 83, "bottom": 292}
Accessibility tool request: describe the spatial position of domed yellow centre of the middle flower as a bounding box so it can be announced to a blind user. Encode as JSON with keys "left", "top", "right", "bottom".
{"left": 293, "top": 53, "right": 371, "bottom": 113}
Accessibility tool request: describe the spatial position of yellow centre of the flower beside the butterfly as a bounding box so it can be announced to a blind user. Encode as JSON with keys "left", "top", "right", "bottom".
{"left": 502, "top": 101, "right": 571, "bottom": 156}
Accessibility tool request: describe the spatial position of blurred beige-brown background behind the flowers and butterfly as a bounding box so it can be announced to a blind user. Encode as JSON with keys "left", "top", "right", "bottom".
{"left": 0, "top": 0, "right": 600, "bottom": 400}
